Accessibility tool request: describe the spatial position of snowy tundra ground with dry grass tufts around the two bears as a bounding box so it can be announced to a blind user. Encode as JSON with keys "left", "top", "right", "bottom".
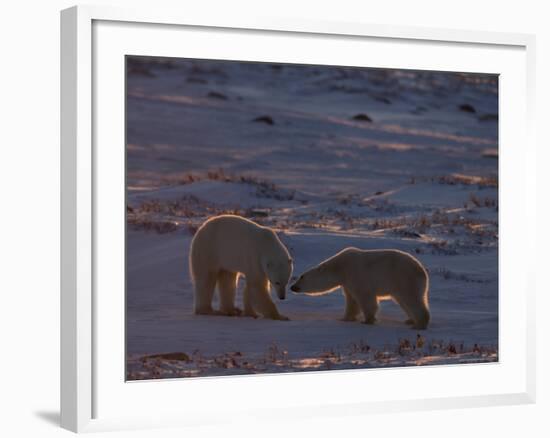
{"left": 126, "top": 58, "right": 498, "bottom": 379}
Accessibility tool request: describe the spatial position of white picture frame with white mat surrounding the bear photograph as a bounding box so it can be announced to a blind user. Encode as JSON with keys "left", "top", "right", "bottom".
{"left": 61, "top": 6, "right": 536, "bottom": 432}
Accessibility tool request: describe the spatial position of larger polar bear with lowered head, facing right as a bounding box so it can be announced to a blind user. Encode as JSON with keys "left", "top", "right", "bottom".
{"left": 189, "top": 215, "right": 292, "bottom": 320}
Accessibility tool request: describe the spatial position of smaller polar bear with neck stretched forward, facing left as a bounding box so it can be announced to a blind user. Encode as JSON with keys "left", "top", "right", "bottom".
{"left": 290, "top": 248, "right": 430, "bottom": 329}
